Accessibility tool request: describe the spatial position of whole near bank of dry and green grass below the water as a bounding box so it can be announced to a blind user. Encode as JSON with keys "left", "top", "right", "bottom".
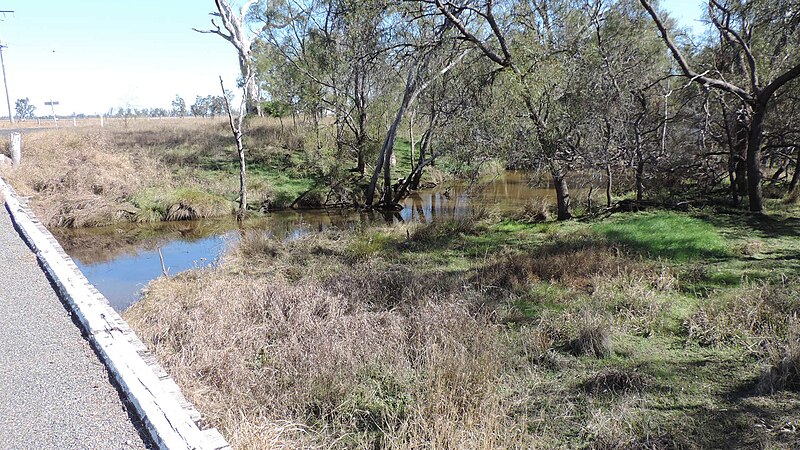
{"left": 126, "top": 205, "right": 800, "bottom": 448}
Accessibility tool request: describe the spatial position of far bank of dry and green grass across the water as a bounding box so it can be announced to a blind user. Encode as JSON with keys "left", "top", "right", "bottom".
{"left": 0, "top": 118, "right": 325, "bottom": 228}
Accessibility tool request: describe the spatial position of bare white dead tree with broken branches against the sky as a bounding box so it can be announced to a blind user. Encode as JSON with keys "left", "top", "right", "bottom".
{"left": 194, "top": 0, "right": 269, "bottom": 116}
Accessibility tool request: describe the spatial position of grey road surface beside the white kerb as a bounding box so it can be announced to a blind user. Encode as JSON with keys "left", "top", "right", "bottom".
{"left": 0, "top": 206, "right": 148, "bottom": 449}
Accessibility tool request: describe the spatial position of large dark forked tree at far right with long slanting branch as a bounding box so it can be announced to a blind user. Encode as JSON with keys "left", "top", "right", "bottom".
{"left": 640, "top": 0, "right": 800, "bottom": 213}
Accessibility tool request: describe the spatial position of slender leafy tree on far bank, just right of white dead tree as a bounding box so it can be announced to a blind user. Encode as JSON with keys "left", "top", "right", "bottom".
{"left": 265, "top": 0, "right": 402, "bottom": 174}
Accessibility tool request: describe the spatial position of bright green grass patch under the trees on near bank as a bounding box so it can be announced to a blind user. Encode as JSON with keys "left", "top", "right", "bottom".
{"left": 593, "top": 212, "right": 730, "bottom": 261}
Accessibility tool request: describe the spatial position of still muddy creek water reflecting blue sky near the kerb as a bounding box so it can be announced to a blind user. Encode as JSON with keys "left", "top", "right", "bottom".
{"left": 54, "top": 171, "right": 554, "bottom": 311}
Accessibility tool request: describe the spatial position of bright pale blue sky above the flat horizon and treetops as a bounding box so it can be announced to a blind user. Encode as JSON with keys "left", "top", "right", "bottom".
{"left": 0, "top": 0, "right": 702, "bottom": 116}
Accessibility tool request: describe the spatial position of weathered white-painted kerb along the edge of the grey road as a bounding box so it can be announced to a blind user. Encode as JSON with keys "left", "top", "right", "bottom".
{"left": 0, "top": 178, "right": 230, "bottom": 450}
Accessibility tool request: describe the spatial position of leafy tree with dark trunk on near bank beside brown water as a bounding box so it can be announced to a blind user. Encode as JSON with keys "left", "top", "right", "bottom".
{"left": 421, "top": 0, "right": 608, "bottom": 220}
